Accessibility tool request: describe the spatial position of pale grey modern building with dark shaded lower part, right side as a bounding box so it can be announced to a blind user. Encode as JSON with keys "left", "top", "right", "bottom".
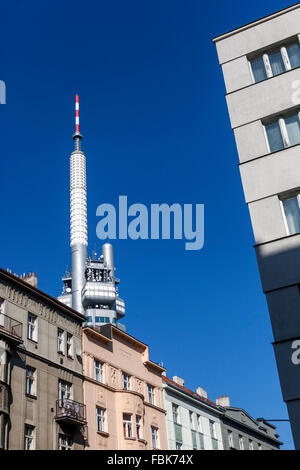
{"left": 214, "top": 3, "right": 300, "bottom": 449}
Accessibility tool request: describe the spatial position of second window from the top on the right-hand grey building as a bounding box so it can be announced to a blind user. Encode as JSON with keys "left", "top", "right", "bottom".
{"left": 265, "top": 113, "right": 300, "bottom": 152}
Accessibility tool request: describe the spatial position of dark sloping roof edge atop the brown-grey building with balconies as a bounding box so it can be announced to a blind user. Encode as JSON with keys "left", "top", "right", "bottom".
{"left": 0, "top": 268, "right": 86, "bottom": 322}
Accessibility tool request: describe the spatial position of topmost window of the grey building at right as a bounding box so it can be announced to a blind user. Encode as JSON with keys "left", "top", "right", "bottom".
{"left": 250, "top": 40, "right": 300, "bottom": 83}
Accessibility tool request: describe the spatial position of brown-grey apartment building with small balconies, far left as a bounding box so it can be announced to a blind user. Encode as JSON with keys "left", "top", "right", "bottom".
{"left": 0, "top": 269, "right": 86, "bottom": 450}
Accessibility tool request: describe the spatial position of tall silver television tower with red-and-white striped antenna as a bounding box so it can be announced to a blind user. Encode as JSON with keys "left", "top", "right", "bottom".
{"left": 58, "top": 95, "right": 125, "bottom": 330}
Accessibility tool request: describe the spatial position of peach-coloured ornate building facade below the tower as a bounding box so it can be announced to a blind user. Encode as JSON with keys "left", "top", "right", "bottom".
{"left": 82, "top": 324, "right": 167, "bottom": 450}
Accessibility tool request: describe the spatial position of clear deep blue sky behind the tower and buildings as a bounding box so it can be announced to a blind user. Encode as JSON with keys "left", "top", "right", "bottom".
{"left": 0, "top": 0, "right": 292, "bottom": 448}
